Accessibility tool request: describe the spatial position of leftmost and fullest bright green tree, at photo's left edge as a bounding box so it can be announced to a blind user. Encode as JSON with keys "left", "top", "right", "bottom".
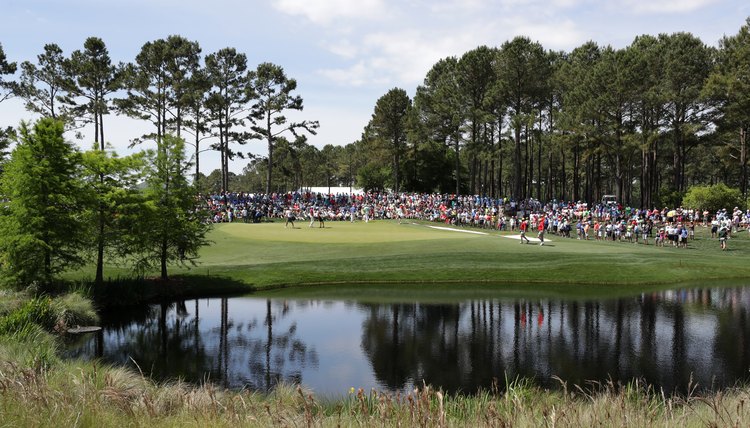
{"left": 0, "top": 118, "right": 84, "bottom": 287}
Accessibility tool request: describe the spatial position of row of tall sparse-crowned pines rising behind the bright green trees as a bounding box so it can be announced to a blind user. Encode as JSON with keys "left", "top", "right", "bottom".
{"left": 0, "top": 35, "right": 319, "bottom": 196}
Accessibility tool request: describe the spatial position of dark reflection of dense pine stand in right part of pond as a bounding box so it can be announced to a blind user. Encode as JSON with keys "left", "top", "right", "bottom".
{"left": 361, "top": 288, "right": 750, "bottom": 392}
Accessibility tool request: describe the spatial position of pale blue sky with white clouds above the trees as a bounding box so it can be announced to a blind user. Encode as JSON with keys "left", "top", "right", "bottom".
{"left": 0, "top": 0, "right": 750, "bottom": 173}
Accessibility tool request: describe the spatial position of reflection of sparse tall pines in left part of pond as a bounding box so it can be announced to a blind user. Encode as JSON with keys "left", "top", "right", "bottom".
{"left": 68, "top": 298, "right": 318, "bottom": 390}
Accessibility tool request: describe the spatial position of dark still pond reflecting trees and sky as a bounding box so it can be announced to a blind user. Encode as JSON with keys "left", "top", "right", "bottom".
{"left": 66, "top": 287, "right": 750, "bottom": 396}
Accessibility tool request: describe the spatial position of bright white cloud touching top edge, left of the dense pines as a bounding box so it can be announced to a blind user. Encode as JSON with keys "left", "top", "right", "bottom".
{"left": 273, "top": 0, "right": 388, "bottom": 25}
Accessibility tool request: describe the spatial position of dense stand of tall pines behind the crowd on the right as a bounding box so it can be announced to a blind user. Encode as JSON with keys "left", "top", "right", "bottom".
{"left": 231, "top": 19, "right": 750, "bottom": 207}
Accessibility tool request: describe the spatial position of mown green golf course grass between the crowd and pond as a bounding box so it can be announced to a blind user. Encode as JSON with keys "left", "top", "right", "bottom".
{"left": 140, "top": 221, "right": 750, "bottom": 291}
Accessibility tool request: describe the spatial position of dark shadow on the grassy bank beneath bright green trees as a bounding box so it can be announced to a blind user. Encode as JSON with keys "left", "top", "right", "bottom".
{"left": 70, "top": 275, "right": 255, "bottom": 307}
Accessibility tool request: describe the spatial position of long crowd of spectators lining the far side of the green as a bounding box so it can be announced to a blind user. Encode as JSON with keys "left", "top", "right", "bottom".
{"left": 204, "top": 192, "right": 750, "bottom": 246}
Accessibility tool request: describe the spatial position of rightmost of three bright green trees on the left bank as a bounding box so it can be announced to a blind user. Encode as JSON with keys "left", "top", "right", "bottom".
{"left": 127, "top": 134, "right": 208, "bottom": 280}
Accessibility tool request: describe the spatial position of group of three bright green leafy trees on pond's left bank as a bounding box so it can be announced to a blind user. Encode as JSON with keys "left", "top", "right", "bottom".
{"left": 0, "top": 118, "right": 209, "bottom": 290}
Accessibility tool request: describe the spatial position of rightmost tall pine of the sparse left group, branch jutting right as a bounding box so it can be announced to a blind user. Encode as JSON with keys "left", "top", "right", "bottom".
{"left": 250, "top": 62, "right": 318, "bottom": 193}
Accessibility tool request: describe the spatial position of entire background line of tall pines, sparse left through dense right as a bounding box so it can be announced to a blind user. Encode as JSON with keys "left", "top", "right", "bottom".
{"left": 0, "top": 19, "right": 750, "bottom": 207}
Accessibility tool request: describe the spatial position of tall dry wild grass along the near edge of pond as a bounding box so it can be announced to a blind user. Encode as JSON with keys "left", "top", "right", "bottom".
{"left": 0, "top": 354, "right": 750, "bottom": 427}
